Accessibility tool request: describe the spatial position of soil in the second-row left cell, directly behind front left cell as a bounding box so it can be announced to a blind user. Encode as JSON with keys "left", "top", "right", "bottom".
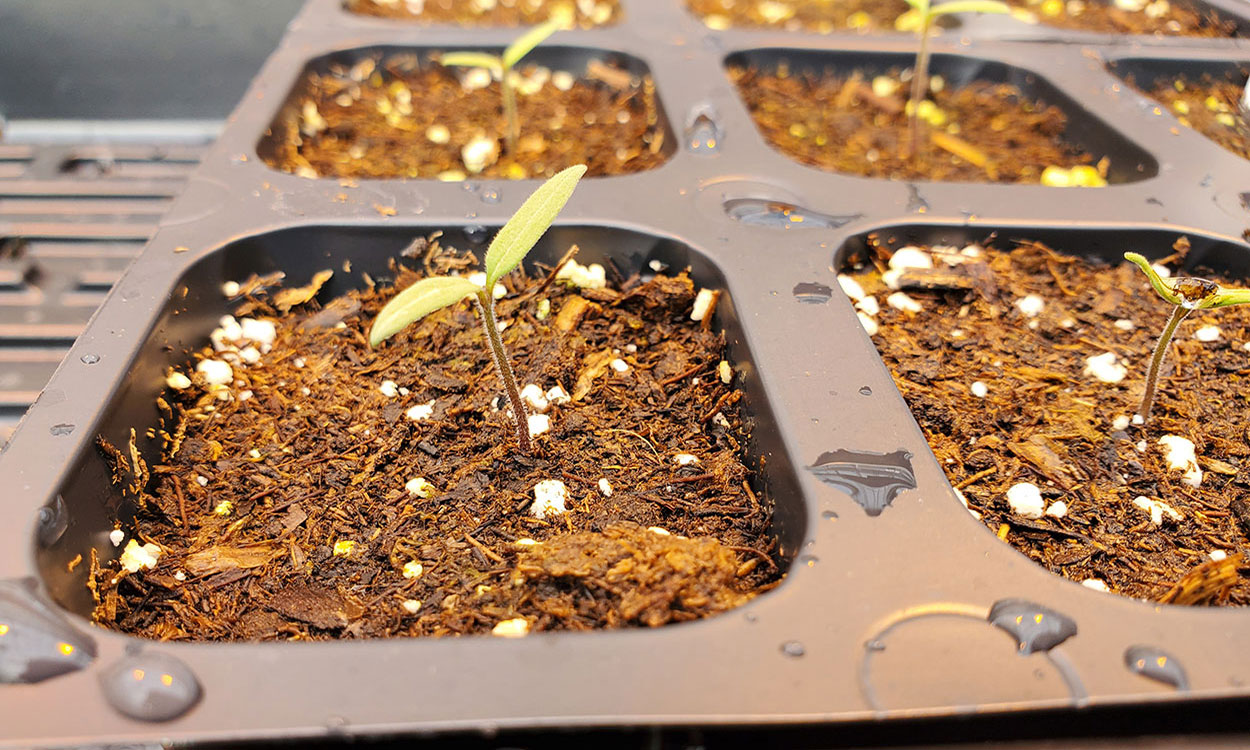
{"left": 261, "top": 55, "right": 668, "bottom": 180}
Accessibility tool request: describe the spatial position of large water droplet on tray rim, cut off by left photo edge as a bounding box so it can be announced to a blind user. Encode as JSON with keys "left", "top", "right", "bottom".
{"left": 0, "top": 580, "right": 95, "bottom": 684}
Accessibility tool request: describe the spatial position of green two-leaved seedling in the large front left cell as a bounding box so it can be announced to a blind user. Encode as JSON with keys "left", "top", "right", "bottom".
{"left": 369, "top": 164, "right": 586, "bottom": 453}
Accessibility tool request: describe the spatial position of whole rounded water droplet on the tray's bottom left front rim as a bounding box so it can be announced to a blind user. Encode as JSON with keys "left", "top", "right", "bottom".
{"left": 100, "top": 651, "right": 201, "bottom": 721}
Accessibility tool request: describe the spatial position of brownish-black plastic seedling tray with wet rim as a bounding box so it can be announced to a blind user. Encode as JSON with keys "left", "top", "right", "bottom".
{"left": 0, "top": 0, "right": 1250, "bottom": 748}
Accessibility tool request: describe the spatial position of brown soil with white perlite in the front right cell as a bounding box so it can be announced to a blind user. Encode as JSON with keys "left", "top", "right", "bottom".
{"left": 850, "top": 241, "right": 1250, "bottom": 605}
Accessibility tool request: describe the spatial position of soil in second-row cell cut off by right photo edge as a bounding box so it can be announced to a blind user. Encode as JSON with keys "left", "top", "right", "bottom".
{"left": 1129, "top": 71, "right": 1250, "bottom": 159}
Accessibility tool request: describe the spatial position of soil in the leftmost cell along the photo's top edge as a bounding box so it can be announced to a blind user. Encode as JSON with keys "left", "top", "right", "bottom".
{"left": 344, "top": 0, "right": 621, "bottom": 29}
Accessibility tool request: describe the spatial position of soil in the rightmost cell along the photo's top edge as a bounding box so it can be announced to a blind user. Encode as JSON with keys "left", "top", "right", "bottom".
{"left": 1015, "top": 0, "right": 1238, "bottom": 38}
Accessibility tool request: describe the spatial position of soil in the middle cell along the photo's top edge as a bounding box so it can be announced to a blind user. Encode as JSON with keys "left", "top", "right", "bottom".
{"left": 686, "top": 0, "right": 909, "bottom": 34}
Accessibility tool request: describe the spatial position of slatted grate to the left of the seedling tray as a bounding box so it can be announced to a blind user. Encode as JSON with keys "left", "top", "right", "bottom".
{"left": 0, "top": 143, "right": 206, "bottom": 448}
